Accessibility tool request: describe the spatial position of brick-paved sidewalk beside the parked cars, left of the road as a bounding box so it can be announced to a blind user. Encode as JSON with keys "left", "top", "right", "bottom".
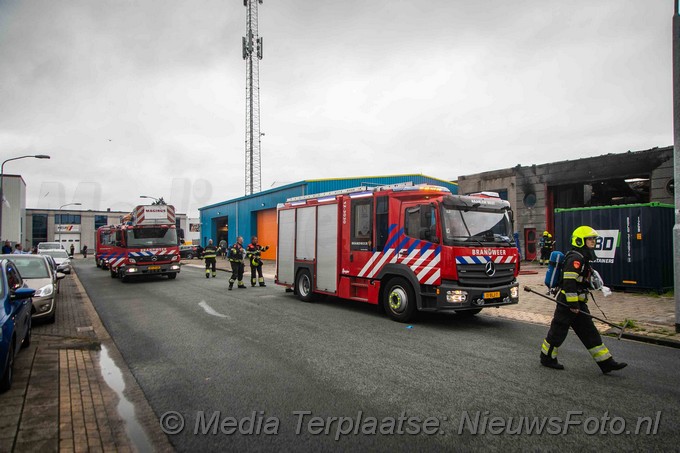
{"left": 0, "top": 259, "right": 172, "bottom": 452}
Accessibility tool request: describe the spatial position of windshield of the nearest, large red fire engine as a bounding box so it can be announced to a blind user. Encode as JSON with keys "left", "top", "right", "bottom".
{"left": 443, "top": 207, "right": 513, "bottom": 247}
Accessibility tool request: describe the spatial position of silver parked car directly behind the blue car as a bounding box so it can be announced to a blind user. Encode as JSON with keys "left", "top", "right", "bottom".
{"left": 0, "top": 255, "right": 66, "bottom": 323}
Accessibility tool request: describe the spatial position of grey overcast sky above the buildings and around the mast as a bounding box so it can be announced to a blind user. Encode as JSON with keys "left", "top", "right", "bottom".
{"left": 0, "top": 0, "right": 673, "bottom": 215}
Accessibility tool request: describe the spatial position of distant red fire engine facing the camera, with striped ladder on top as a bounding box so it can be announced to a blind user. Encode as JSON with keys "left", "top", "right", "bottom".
{"left": 102, "top": 205, "right": 180, "bottom": 281}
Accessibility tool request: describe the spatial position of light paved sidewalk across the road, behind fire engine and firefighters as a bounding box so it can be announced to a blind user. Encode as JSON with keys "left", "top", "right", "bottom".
{"left": 182, "top": 257, "right": 680, "bottom": 340}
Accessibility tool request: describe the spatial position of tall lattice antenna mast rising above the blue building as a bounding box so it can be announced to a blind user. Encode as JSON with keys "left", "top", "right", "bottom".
{"left": 243, "top": 0, "right": 262, "bottom": 195}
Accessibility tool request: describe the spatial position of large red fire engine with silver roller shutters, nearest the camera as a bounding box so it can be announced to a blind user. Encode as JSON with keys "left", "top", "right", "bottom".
{"left": 276, "top": 184, "right": 519, "bottom": 322}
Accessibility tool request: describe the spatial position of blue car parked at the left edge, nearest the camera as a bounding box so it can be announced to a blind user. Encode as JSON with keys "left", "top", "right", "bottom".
{"left": 0, "top": 259, "right": 35, "bottom": 392}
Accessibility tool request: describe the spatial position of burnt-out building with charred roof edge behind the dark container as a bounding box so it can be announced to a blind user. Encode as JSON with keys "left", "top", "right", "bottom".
{"left": 458, "top": 146, "right": 674, "bottom": 261}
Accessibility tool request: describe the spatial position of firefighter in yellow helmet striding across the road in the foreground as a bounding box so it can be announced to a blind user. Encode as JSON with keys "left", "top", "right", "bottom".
{"left": 541, "top": 226, "right": 627, "bottom": 374}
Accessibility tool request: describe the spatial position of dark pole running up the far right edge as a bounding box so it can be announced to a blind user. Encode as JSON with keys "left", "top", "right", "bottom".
{"left": 673, "top": 0, "right": 680, "bottom": 333}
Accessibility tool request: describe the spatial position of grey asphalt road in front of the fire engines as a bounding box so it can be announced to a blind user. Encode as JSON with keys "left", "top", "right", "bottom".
{"left": 77, "top": 260, "right": 680, "bottom": 451}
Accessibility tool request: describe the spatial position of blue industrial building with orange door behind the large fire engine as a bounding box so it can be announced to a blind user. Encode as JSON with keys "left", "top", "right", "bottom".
{"left": 199, "top": 174, "right": 458, "bottom": 259}
